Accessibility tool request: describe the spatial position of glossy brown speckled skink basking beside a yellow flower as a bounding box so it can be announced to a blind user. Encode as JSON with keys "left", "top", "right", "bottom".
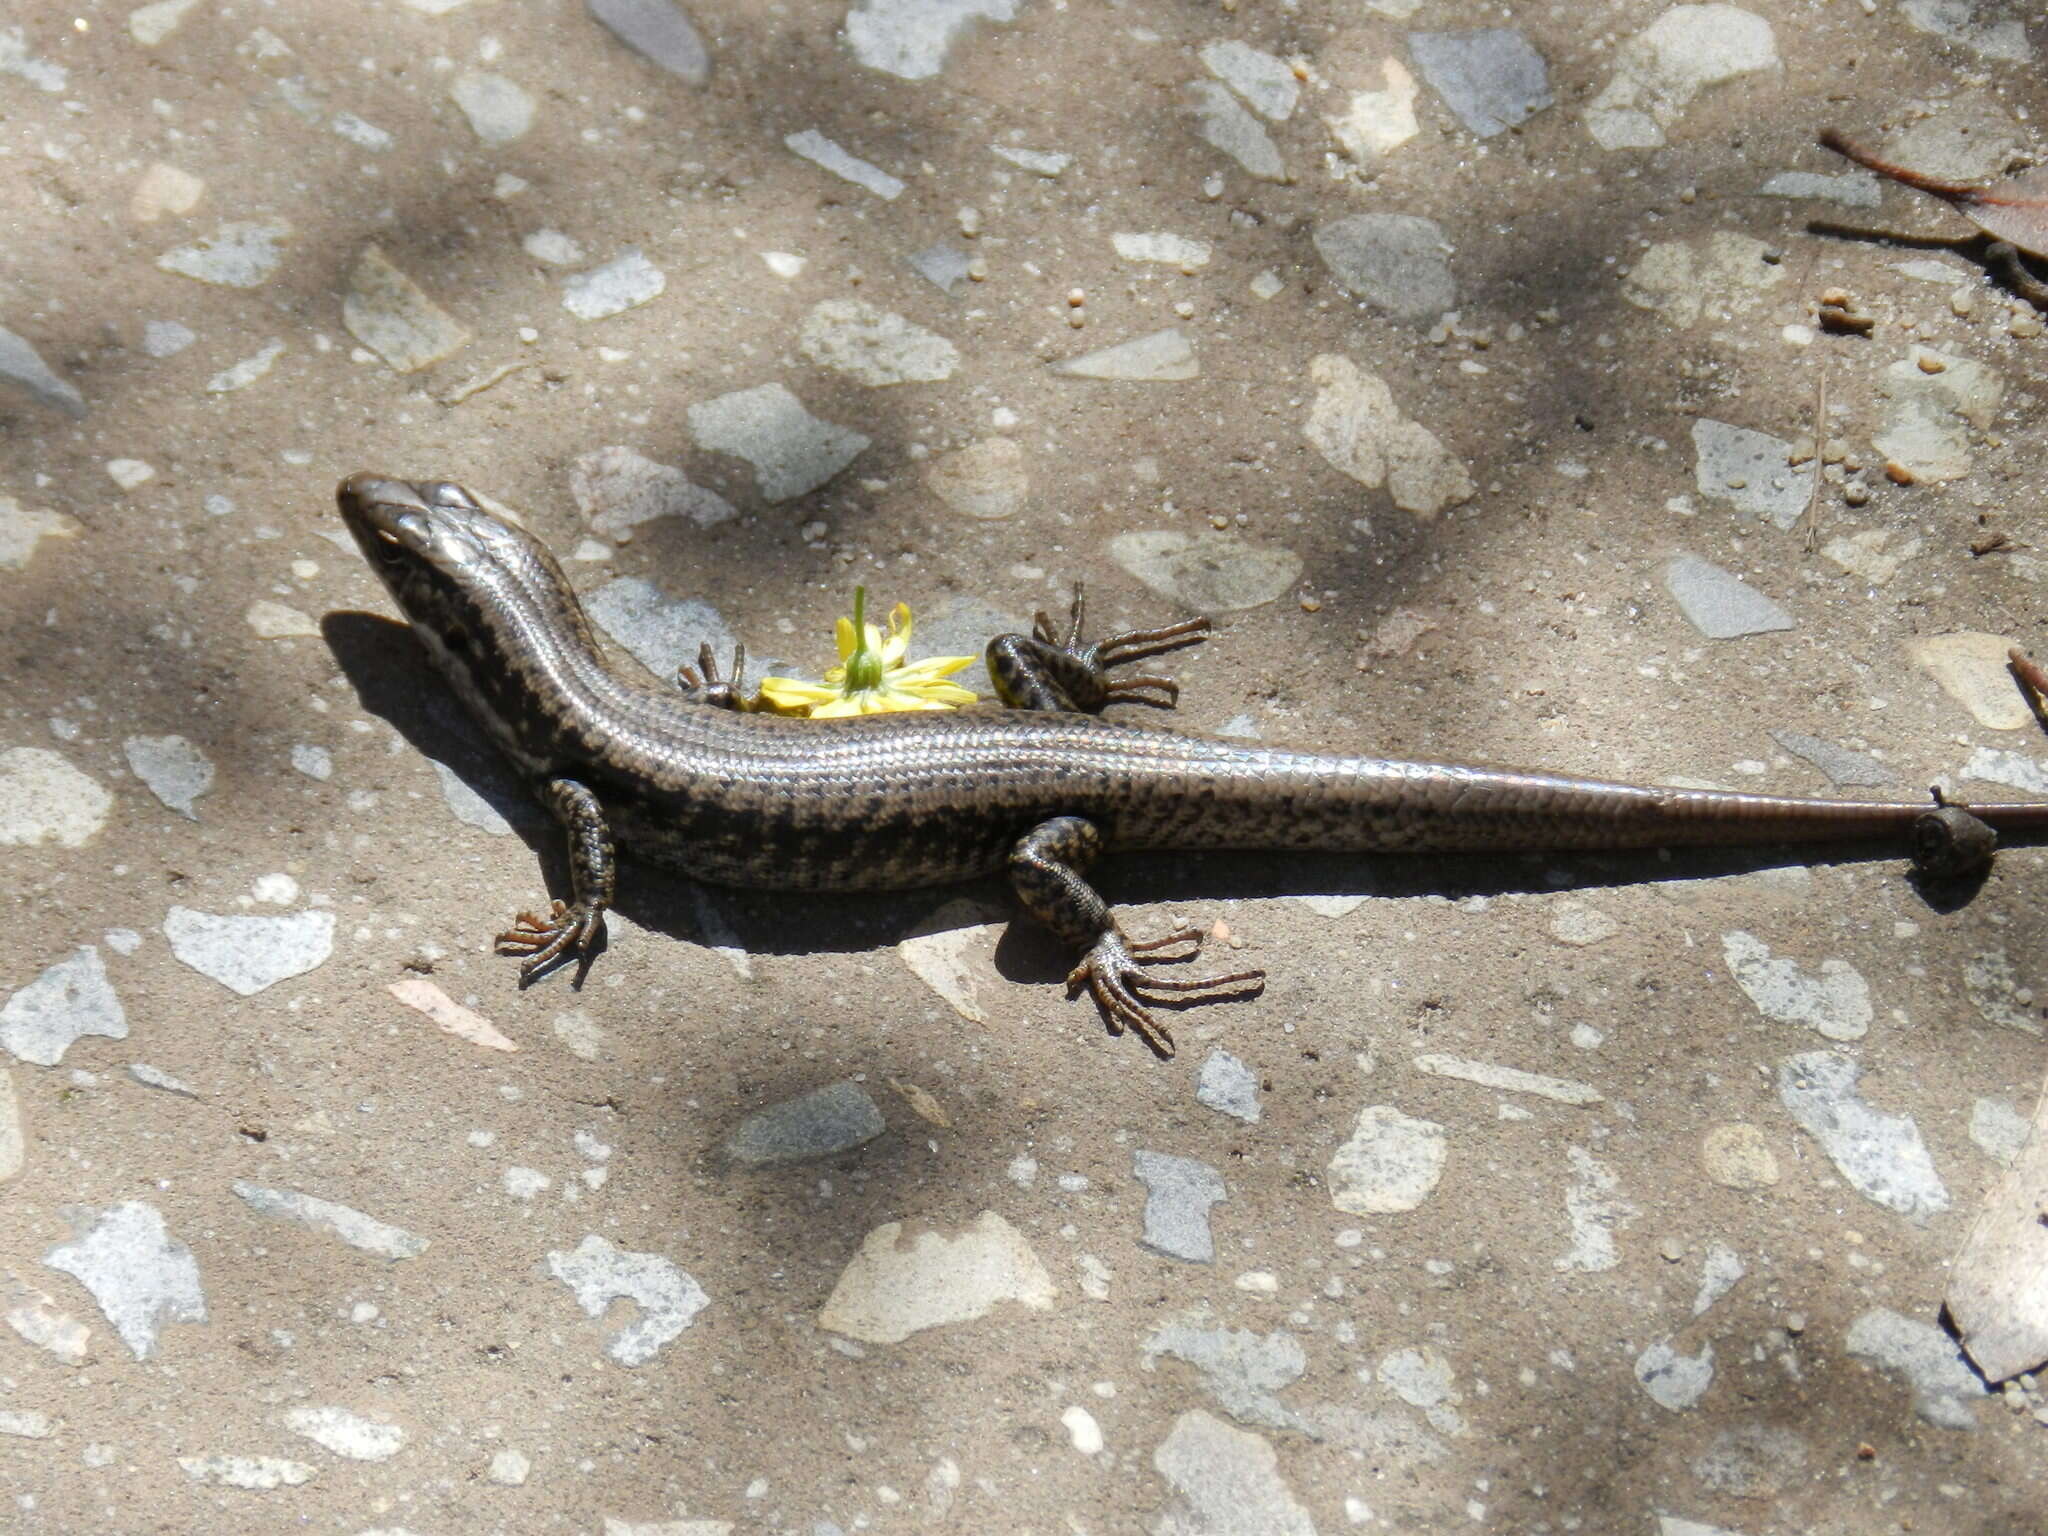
{"left": 338, "top": 475, "right": 2048, "bottom": 1057}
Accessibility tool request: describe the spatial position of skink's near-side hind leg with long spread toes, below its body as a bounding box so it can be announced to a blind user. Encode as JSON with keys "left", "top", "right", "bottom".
{"left": 1010, "top": 815, "right": 1266, "bottom": 1059}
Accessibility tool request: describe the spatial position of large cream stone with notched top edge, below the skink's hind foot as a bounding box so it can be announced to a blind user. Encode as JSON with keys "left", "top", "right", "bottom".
{"left": 817, "top": 1210, "right": 1057, "bottom": 1343}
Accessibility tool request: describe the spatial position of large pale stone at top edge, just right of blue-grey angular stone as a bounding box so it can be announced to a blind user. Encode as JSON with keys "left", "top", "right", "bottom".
{"left": 1585, "top": 4, "right": 1780, "bottom": 150}
